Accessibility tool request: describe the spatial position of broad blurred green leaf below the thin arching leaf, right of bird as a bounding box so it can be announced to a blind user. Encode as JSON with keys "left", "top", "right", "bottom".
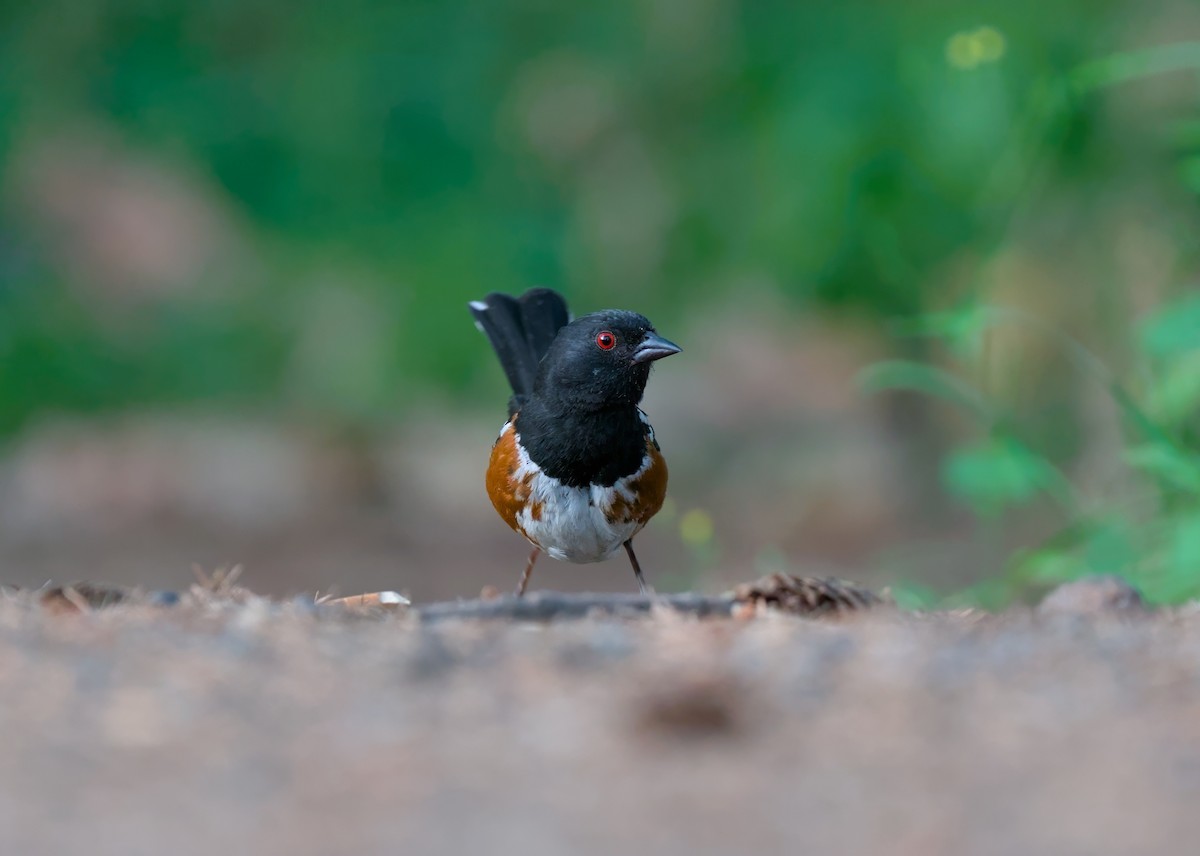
{"left": 942, "top": 437, "right": 1060, "bottom": 517}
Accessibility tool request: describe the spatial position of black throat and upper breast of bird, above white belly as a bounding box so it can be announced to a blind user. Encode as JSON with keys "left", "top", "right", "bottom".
{"left": 516, "top": 396, "right": 648, "bottom": 487}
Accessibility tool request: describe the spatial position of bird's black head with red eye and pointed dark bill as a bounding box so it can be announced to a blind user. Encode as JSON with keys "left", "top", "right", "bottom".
{"left": 534, "top": 310, "right": 679, "bottom": 411}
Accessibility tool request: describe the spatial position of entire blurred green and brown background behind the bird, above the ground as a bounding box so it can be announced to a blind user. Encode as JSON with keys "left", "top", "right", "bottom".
{"left": 0, "top": 0, "right": 1200, "bottom": 603}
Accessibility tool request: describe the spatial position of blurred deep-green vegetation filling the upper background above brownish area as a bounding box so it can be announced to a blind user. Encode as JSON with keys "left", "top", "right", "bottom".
{"left": 0, "top": 0, "right": 1166, "bottom": 430}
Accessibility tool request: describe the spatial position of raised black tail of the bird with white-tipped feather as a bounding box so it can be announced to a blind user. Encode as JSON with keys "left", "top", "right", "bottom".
{"left": 470, "top": 288, "right": 570, "bottom": 402}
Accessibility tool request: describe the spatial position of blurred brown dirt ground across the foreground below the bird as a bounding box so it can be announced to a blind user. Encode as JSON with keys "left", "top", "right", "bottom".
{"left": 0, "top": 573, "right": 1200, "bottom": 856}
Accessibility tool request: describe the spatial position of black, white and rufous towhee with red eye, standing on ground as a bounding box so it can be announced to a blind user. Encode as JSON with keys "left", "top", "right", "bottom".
{"left": 470, "top": 288, "right": 679, "bottom": 594}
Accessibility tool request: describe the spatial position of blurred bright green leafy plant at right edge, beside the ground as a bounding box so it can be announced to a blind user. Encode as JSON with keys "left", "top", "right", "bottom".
{"left": 864, "top": 291, "right": 1200, "bottom": 606}
